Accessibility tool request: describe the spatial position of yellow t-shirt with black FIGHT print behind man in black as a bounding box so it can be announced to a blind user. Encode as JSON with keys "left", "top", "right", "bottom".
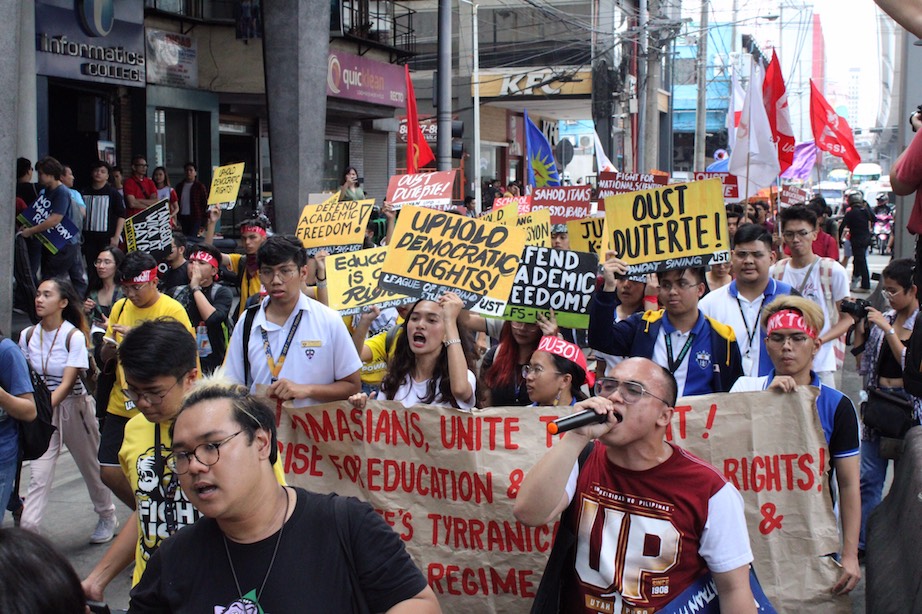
{"left": 118, "top": 415, "right": 285, "bottom": 586}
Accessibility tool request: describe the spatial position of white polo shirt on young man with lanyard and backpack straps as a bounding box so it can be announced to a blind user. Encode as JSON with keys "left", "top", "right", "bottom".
{"left": 224, "top": 294, "right": 362, "bottom": 407}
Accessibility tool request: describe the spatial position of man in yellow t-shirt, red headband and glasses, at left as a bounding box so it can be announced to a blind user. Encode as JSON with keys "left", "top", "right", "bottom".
{"left": 99, "top": 252, "right": 195, "bottom": 509}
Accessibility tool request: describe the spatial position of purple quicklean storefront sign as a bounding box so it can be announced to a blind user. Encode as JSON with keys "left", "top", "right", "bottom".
{"left": 327, "top": 49, "right": 407, "bottom": 107}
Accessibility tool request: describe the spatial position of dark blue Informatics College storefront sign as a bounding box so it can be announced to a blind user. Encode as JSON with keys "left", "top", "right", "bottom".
{"left": 35, "top": 0, "right": 146, "bottom": 87}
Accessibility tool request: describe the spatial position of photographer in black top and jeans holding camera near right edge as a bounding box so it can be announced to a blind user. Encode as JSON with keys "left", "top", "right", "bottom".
{"left": 853, "top": 258, "right": 922, "bottom": 558}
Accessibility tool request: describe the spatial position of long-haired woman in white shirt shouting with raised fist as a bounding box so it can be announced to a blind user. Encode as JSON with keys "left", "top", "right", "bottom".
{"left": 349, "top": 292, "right": 477, "bottom": 411}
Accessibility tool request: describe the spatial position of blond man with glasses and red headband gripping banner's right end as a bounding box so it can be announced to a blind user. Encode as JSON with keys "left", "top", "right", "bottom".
{"left": 730, "top": 298, "right": 861, "bottom": 595}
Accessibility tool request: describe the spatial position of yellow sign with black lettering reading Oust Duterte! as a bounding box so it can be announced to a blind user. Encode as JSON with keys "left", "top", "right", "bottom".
{"left": 605, "top": 179, "right": 730, "bottom": 275}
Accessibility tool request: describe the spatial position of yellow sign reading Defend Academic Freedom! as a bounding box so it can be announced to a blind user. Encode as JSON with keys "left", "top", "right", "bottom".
{"left": 295, "top": 199, "right": 375, "bottom": 256}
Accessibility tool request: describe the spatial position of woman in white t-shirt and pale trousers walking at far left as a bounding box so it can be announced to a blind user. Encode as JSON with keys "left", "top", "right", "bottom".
{"left": 19, "top": 278, "right": 118, "bottom": 544}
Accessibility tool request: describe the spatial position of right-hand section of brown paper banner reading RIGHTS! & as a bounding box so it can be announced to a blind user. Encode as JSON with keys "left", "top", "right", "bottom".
{"left": 667, "top": 386, "right": 851, "bottom": 614}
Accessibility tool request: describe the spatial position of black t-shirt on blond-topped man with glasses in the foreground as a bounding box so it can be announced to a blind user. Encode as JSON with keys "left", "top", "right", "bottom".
{"left": 129, "top": 488, "right": 426, "bottom": 614}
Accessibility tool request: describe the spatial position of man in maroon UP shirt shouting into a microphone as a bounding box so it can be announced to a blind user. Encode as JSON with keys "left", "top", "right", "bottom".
{"left": 514, "top": 358, "right": 756, "bottom": 614}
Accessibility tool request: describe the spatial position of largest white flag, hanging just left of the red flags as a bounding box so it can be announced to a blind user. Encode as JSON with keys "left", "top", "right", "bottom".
{"left": 729, "top": 62, "right": 781, "bottom": 198}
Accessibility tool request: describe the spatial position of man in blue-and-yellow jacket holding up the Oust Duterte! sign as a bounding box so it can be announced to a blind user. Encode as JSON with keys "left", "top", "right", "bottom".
{"left": 589, "top": 251, "right": 743, "bottom": 396}
